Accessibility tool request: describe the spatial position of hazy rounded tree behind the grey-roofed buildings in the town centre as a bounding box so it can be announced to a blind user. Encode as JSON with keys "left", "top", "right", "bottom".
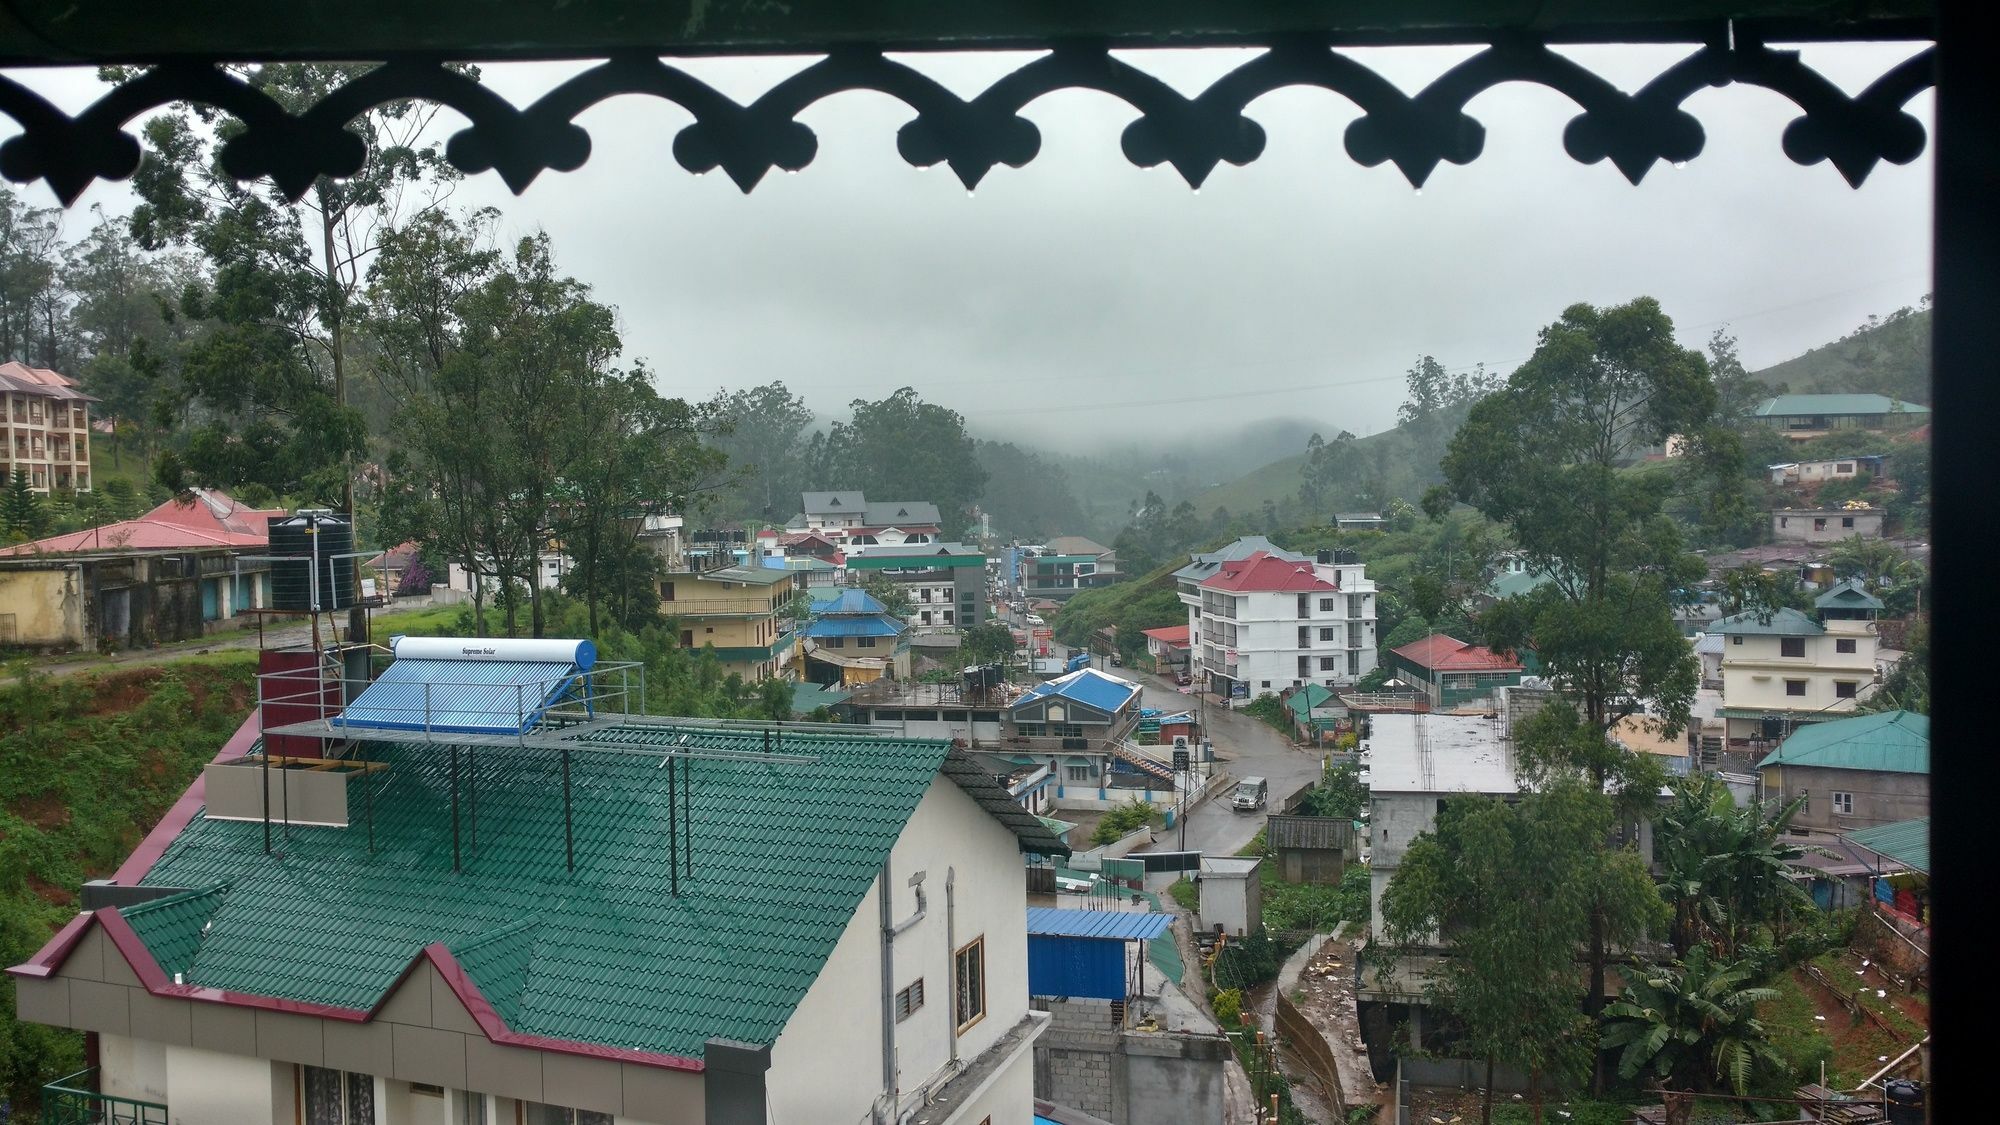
{"left": 820, "top": 386, "right": 986, "bottom": 538}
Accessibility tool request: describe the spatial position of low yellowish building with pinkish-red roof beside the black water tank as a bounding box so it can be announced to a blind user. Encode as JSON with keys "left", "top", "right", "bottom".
{"left": 0, "top": 488, "right": 290, "bottom": 649}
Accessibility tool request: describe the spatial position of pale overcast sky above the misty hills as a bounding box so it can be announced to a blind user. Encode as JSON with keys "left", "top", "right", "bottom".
{"left": 3, "top": 44, "right": 1932, "bottom": 446}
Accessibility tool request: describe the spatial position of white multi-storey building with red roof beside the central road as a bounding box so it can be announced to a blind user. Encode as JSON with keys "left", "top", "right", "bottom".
{"left": 1174, "top": 536, "right": 1376, "bottom": 697}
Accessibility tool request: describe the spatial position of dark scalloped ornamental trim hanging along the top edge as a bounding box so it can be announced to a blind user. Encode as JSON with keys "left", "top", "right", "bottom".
{"left": 0, "top": 38, "right": 1936, "bottom": 204}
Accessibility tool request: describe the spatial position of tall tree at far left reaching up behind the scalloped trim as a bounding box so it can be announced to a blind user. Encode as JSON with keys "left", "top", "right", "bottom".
{"left": 124, "top": 62, "right": 458, "bottom": 568}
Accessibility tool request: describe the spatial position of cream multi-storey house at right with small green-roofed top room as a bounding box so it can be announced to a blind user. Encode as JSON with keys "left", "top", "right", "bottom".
{"left": 1708, "top": 579, "right": 1882, "bottom": 749}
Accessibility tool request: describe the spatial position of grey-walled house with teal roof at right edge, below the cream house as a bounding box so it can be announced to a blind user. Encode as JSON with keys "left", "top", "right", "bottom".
{"left": 1758, "top": 711, "right": 1930, "bottom": 833}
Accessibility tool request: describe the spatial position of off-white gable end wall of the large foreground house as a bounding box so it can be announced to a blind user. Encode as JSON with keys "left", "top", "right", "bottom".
{"left": 768, "top": 777, "right": 1032, "bottom": 1125}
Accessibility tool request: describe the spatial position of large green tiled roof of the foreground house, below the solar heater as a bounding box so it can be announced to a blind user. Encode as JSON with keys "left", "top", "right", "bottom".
{"left": 139, "top": 727, "right": 1066, "bottom": 1057}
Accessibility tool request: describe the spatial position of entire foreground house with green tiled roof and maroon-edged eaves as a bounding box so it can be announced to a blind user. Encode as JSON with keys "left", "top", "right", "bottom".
{"left": 10, "top": 688, "right": 1068, "bottom": 1125}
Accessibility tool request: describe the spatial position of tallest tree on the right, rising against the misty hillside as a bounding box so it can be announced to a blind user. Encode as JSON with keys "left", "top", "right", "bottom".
{"left": 1444, "top": 296, "right": 1742, "bottom": 1064}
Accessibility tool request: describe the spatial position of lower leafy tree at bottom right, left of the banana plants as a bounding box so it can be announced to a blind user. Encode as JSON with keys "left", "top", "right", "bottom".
{"left": 1382, "top": 783, "right": 1660, "bottom": 1121}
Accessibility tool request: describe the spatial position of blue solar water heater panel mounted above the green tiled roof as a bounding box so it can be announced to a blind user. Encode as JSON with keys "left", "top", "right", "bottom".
{"left": 332, "top": 659, "right": 578, "bottom": 735}
